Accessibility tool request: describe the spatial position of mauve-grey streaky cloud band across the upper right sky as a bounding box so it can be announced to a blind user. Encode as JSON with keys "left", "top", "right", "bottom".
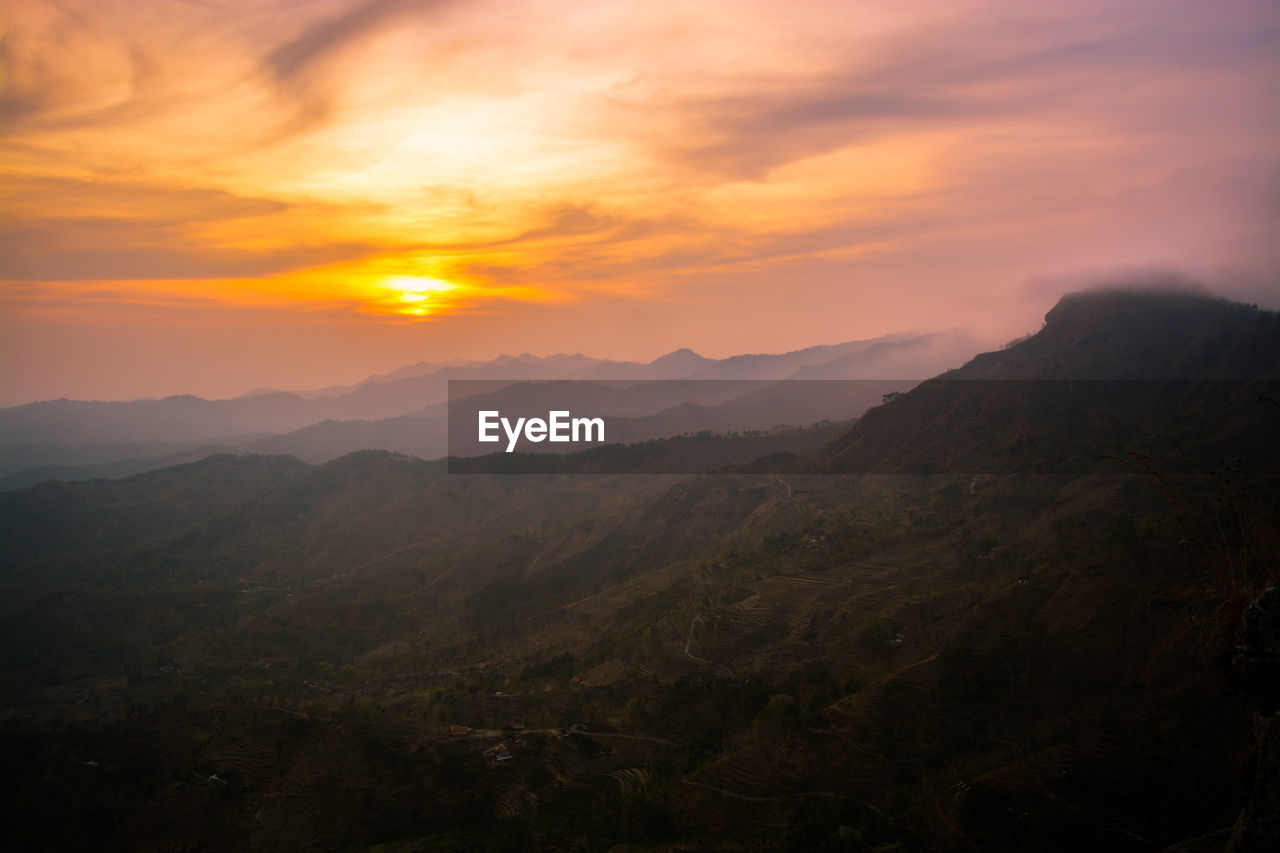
{"left": 613, "top": 3, "right": 1280, "bottom": 182}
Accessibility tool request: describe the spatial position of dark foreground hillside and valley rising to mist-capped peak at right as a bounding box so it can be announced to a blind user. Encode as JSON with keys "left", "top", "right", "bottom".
{"left": 0, "top": 281, "right": 1280, "bottom": 853}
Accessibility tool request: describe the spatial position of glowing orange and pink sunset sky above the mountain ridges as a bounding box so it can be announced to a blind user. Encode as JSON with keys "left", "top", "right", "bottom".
{"left": 0, "top": 0, "right": 1280, "bottom": 405}
